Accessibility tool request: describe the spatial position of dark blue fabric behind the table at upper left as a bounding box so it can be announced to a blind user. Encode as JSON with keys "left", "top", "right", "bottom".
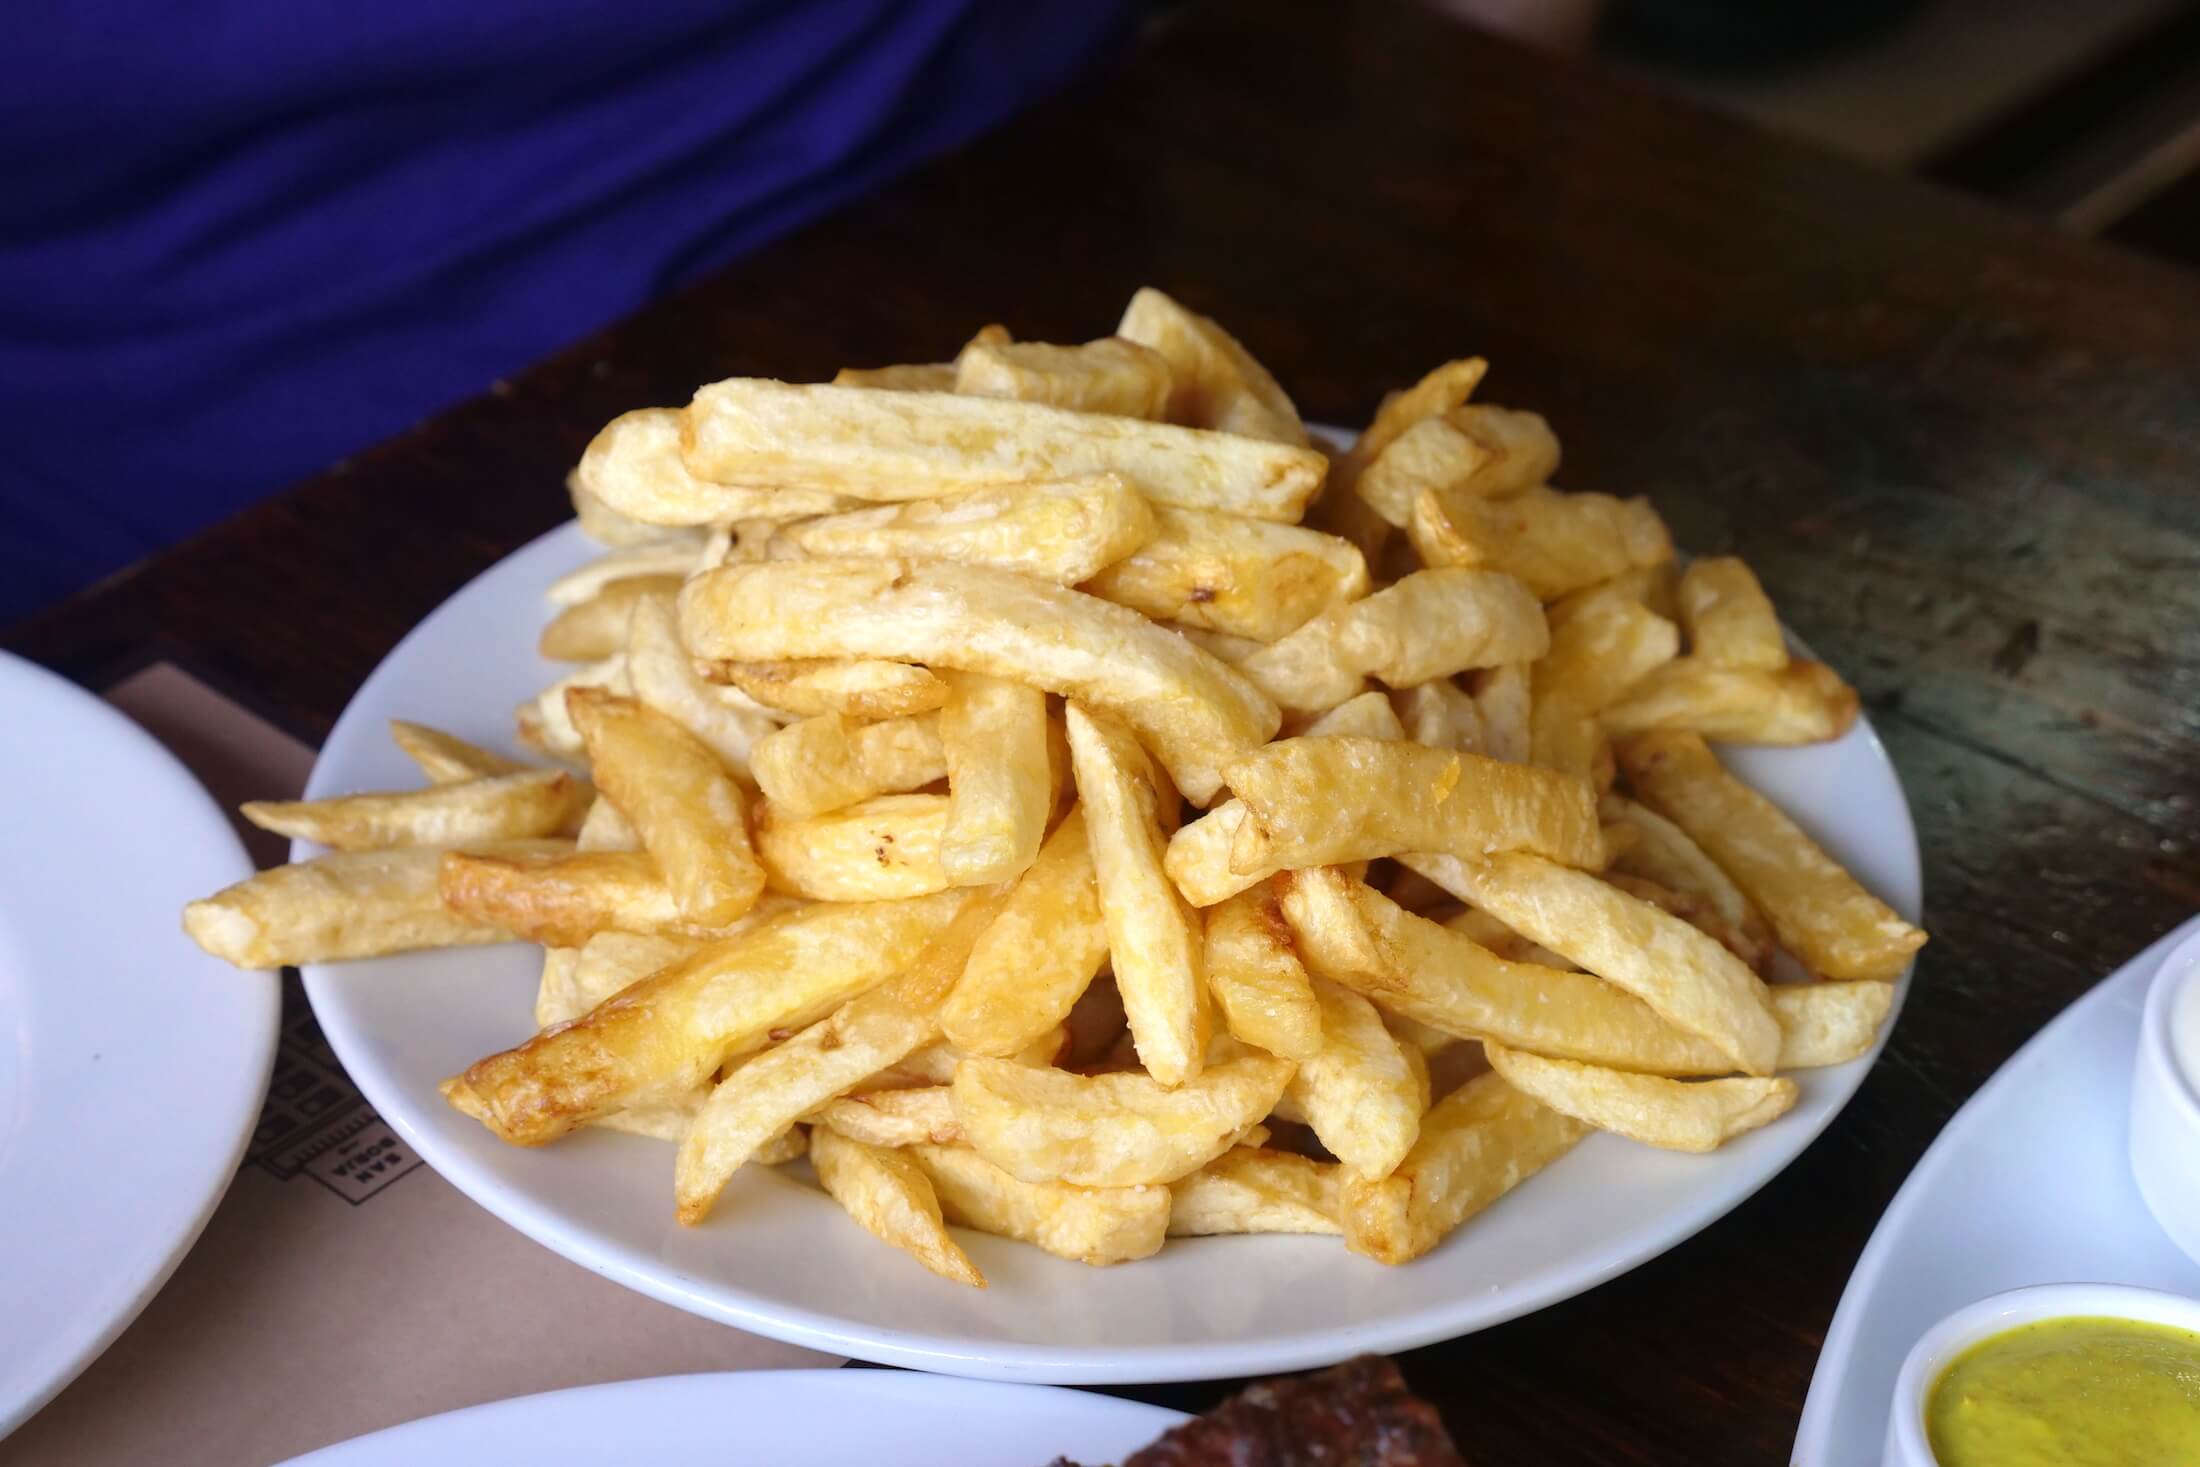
{"left": 0, "top": 0, "right": 1129, "bottom": 622}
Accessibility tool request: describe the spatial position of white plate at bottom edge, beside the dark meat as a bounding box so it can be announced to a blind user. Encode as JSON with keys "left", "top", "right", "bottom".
{"left": 290, "top": 1370, "right": 1184, "bottom": 1467}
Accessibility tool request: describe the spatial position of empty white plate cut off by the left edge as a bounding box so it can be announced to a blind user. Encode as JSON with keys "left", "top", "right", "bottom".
{"left": 0, "top": 653, "right": 279, "bottom": 1436}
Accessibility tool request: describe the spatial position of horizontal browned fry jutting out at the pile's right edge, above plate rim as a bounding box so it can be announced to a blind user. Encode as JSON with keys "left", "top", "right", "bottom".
{"left": 1604, "top": 658, "right": 1857, "bottom": 743}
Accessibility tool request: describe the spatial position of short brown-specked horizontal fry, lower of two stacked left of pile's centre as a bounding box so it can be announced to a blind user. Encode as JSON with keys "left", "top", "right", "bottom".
{"left": 757, "top": 794, "right": 950, "bottom": 902}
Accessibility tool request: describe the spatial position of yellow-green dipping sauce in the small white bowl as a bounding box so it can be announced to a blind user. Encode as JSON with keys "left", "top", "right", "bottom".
{"left": 1925, "top": 1317, "right": 2200, "bottom": 1467}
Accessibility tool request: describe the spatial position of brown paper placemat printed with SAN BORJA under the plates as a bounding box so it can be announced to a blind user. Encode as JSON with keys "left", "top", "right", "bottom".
{"left": 0, "top": 664, "right": 840, "bottom": 1467}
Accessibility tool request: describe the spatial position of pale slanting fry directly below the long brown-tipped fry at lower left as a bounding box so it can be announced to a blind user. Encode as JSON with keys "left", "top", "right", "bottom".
{"left": 673, "top": 886, "right": 1008, "bottom": 1225}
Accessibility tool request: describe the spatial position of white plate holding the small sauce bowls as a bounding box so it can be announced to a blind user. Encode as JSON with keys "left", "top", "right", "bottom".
{"left": 1795, "top": 917, "right": 2200, "bottom": 1467}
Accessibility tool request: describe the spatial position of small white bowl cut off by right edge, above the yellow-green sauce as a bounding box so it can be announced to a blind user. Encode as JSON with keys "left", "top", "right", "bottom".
{"left": 2132, "top": 937, "right": 2200, "bottom": 1262}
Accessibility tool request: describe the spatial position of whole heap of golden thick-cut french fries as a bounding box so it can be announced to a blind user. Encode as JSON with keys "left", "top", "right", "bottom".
{"left": 185, "top": 290, "right": 1925, "bottom": 1284}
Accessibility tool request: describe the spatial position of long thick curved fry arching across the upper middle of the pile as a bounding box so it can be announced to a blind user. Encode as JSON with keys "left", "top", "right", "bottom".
{"left": 680, "top": 561, "right": 1283, "bottom": 803}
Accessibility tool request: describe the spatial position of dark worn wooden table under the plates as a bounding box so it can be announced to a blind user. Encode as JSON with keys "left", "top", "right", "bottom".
{"left": 7, "top": 0, "right": 2200, "bottom": 1467}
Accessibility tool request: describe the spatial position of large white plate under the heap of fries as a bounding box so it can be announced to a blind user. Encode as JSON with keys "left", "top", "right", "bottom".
{"left": 306, "top": 526, "right": 1918, "bottom": 1383}
